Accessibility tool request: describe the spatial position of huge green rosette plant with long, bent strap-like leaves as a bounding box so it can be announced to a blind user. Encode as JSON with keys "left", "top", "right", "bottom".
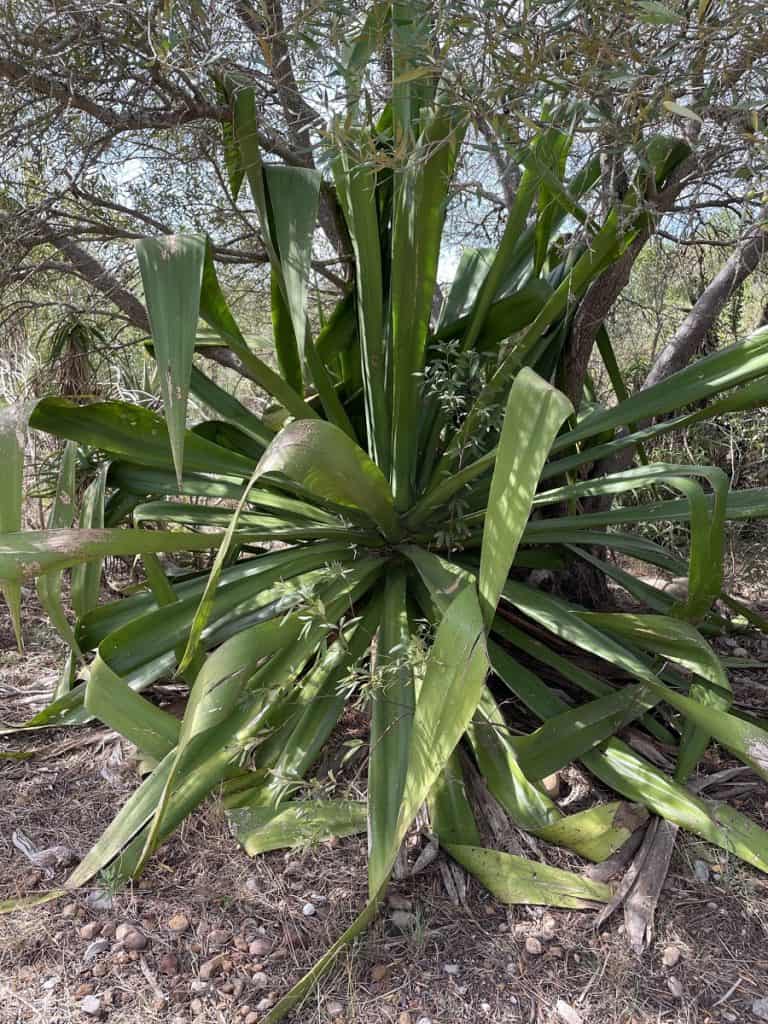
{"left": 0, "top": 12, "right": 768, "bottom": 1021}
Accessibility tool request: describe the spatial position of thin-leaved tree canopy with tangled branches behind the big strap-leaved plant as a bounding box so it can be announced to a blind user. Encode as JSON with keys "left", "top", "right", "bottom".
{"left": 0, "top": 0, "right": 768, "bottom": 402}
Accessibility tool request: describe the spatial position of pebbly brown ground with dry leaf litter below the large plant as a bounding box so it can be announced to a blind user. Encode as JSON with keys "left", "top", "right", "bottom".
{"left": 0, "top": 560, "right": 768, "bottom": 1024}
